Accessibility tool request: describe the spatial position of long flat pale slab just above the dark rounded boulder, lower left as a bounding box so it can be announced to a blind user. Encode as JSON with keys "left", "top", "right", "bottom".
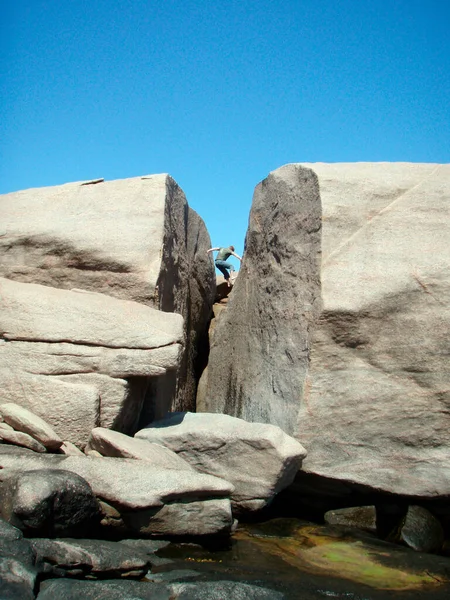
{"left": 0, "top": 447, "right": 234, "bottom": 535}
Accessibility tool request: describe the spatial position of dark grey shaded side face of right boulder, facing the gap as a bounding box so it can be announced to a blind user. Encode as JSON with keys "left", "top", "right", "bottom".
{"left": 201, "top": 165, "right": 321, "bottom": 434}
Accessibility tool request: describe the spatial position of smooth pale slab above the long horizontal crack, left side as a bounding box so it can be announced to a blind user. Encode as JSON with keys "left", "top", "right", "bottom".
{"left": 0, "top": 278, "right": 183, "bottom": 350}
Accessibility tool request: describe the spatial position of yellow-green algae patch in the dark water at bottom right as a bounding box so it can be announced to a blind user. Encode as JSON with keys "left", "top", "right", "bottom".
{"left": 237, "top": 524, "right": 448, "bottom": 591}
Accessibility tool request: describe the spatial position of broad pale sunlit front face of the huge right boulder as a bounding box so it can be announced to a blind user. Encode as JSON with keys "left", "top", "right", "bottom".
{"left": 299, "top": 163, "right": 450, "bottom": 497}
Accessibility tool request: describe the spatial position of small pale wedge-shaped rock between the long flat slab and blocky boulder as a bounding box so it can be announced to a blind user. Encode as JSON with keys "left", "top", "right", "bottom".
{"left": 88, "top": 427, "right": 192, "bottom": 470}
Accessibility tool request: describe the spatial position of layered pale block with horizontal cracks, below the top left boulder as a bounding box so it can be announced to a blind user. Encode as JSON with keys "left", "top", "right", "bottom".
{"left": 0, "top": 278, "right": 184, "bottom": 447}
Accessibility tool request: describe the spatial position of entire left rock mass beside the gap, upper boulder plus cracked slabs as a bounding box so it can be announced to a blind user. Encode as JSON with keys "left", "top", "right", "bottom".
{"left": 0, "top": 174, "right": 215, "bottom": 440}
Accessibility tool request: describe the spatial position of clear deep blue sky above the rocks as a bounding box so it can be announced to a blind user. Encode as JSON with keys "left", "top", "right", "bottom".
{"left": 0, "top": 0, "right": 450, "bottom": 262}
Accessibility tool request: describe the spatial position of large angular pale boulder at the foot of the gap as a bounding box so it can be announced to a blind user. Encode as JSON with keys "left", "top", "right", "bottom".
{"left": 136, "top": 413, "right": 306, "bottom": 513}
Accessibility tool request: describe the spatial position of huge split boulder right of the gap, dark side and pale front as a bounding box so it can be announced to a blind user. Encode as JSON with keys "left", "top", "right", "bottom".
{"left": 205, "top": 163, "right": 450, "bottom": 497}
